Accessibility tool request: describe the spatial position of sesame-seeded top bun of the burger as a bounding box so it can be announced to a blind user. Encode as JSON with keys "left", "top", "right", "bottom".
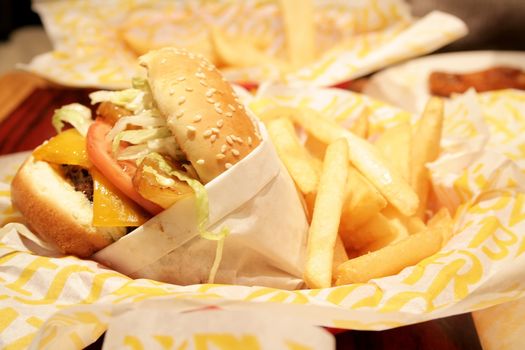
{"left": 139, "top": 47, "right": 260, "bottom": 183}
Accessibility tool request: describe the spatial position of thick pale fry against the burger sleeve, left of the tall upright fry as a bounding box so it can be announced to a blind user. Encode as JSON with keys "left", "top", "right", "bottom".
{"left": 267, "top": 118, "right": 320, "bottom": 196}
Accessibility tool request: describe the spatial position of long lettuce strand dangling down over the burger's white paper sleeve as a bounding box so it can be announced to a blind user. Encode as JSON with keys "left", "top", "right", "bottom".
{"left": 148, "top": 153, "right": 230, "bottom": 283}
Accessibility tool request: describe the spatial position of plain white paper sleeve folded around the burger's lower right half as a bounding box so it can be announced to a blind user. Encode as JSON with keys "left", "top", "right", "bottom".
{"left": 93, "top": 124, "right": 308, "bottom": 289}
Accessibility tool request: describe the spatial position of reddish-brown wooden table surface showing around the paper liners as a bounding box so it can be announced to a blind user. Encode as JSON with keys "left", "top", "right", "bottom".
{"left": 0, "top": 72, "right": 481, "bottom": 350}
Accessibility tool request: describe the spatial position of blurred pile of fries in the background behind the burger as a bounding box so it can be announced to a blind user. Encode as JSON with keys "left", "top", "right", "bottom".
{"left": 119, "top": 0, "right": 320, "bottom": 72}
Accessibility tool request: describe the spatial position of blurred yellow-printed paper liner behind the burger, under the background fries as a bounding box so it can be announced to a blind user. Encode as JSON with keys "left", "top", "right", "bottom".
{"left": 25, "top": 0, "right": 467, "bottom": 89}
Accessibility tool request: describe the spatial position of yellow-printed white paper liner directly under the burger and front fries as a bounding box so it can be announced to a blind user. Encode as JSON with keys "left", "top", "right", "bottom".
{"left": 0, "top": 87, "right": 525, "bottom": 348}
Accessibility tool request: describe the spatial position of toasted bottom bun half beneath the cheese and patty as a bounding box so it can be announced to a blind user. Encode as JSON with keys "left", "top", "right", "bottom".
{"left": 11, "top": 156, "right": 125, "bottom": 257}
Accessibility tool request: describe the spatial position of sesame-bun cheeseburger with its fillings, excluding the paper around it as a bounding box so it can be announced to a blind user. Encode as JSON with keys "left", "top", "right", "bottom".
{"left": 11, "top": 48, "right": 261, "bottom": 257}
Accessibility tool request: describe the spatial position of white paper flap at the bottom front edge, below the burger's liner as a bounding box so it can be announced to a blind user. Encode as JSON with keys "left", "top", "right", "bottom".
{"left": 24, "top": 301, "right": 335, "bottom": 350}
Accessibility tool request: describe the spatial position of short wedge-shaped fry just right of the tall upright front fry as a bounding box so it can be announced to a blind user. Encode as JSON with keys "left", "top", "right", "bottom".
{"left": 339, "top": 165, "right": 387, "bottom": 246}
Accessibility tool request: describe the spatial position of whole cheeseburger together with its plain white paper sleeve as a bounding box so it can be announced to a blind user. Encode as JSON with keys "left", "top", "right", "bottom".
{"left": 12, "top": 48, "right": 307, "bottom": 288}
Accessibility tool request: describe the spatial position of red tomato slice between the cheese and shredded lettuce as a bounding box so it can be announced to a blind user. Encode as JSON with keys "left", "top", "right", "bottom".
{"left": 87, "top": 119, "right": 163, "bottom": 215}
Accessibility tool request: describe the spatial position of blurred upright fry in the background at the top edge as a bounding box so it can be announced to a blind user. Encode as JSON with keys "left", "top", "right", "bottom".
{"left": 276, "top": 0, "right": 315, "bottom": 67}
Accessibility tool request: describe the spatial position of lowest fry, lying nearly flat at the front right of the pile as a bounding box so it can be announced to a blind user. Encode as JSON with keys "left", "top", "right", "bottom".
{"left": 334, "top": 227, "right": 443, "bottom": 286}
